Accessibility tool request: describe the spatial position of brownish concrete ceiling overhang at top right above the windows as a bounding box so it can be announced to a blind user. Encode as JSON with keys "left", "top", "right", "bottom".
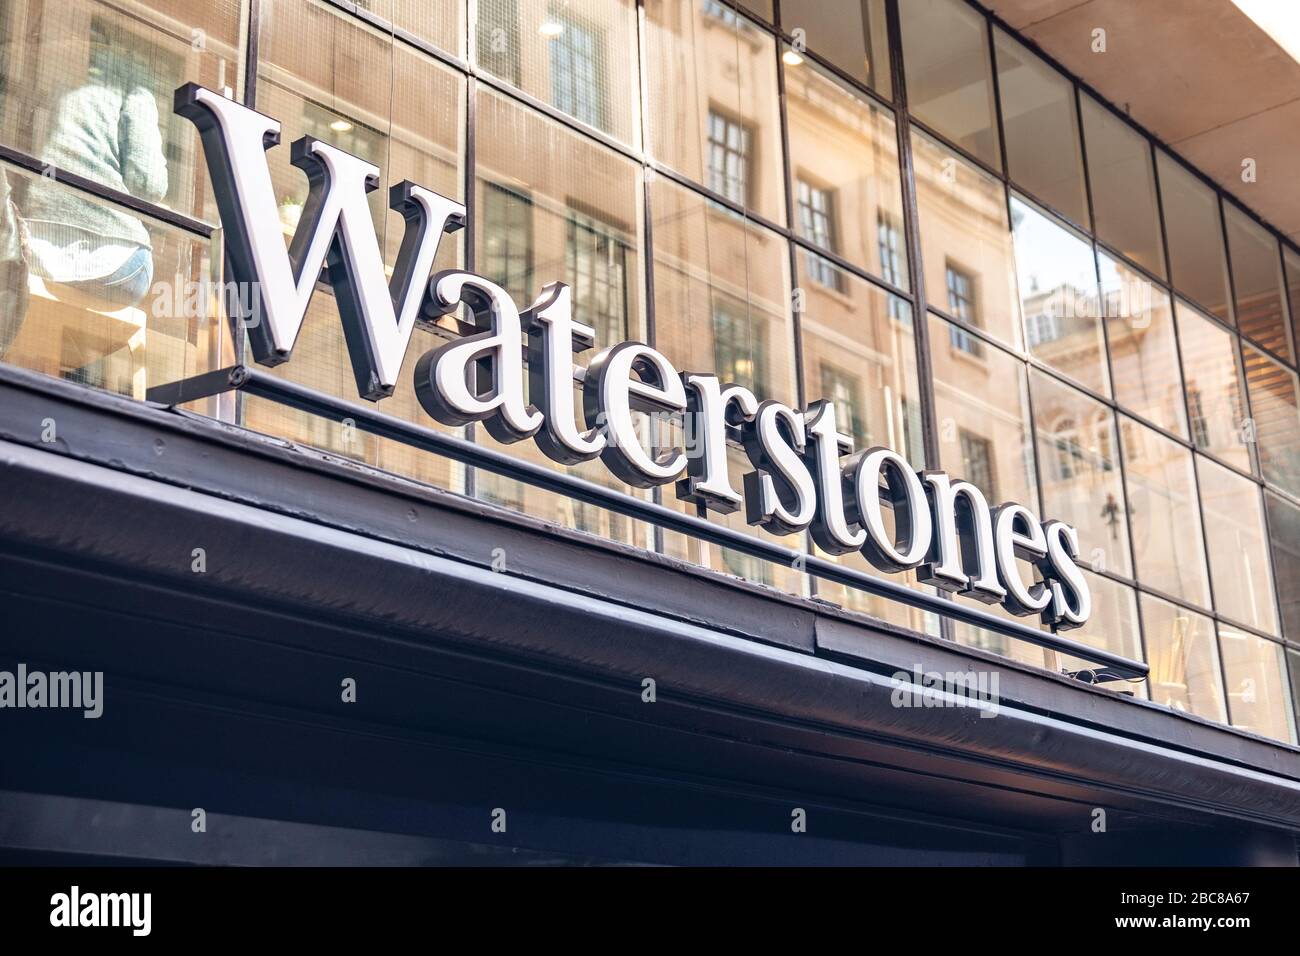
{"left": 983, "top": 0, "right": 1300, "bottom": 243}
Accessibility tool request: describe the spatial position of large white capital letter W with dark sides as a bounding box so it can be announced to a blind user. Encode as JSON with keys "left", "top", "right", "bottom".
{"left": 176, "top": 83, "right": 465, "bottom": 401}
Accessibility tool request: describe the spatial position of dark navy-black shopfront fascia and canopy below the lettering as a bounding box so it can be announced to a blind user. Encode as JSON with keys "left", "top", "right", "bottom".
{"left": 0, "top": 368, "right": 1300, "bottom": 865}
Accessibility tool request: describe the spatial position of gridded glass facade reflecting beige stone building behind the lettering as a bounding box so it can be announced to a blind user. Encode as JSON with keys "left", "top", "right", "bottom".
{"left": 0, "top": 0, "right": 1300, "bottom": 740}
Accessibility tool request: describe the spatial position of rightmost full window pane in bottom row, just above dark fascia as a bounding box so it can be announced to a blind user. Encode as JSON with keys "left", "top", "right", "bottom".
{"left": 1219, "top": 624, "right": 1296, "bottom": 743}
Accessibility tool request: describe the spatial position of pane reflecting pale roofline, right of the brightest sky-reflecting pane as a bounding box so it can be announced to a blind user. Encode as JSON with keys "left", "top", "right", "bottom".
{"left": 1097, "top": 252, "right": 1187, "bottom": 438}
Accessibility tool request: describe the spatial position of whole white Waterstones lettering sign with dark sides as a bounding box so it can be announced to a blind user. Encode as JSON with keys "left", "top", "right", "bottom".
{"left": 176, "top": 83, "right": 1092, "bottom": 630}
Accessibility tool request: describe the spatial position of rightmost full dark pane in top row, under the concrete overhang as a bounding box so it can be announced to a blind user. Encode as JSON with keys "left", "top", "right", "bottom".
{"left": 1223, "top": 203, "right": 1291, "bottom": 359}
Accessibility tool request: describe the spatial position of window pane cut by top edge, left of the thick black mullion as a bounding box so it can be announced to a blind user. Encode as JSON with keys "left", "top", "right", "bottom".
{"left": 781, "top": 0, "right": 893, "bottom": 99}
